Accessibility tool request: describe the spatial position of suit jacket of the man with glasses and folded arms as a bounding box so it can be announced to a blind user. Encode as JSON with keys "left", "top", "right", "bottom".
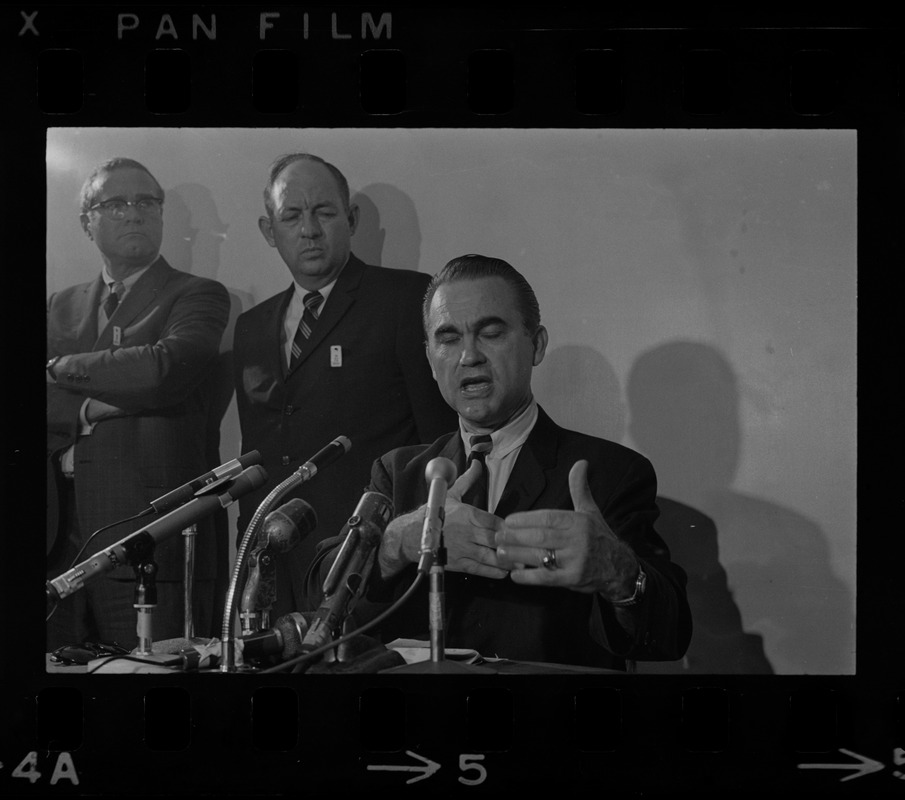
{"left": 47, "top": 257, "right": 229, "bottom": 580}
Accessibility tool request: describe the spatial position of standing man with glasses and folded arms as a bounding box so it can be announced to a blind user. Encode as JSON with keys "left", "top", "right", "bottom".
{"left": 46, "top": 158, "right": 229, "bottom": 649}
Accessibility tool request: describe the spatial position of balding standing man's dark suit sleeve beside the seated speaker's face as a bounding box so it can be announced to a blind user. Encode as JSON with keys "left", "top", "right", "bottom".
{"left": 396, "top": 282, "right": 458, "bottom": 442}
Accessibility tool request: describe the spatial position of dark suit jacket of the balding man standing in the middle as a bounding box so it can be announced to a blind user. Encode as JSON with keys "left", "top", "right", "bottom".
{"left": 233, "top": 255, "right": 455, "bottom": 620}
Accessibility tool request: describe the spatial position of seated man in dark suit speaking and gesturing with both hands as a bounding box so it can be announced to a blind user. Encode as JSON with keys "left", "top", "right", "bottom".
{"left": 308, "top": 255, "right": 691, "bottom": 669}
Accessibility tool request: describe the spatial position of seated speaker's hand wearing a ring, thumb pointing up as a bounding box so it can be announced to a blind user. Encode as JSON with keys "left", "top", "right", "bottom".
{"left": 496, "top": 460, "right": 639, "bottom": 600}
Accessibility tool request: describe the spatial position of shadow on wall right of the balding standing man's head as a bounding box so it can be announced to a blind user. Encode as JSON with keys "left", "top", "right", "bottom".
{"left": 352, "top": 183, "right": 424, "bottom": 274}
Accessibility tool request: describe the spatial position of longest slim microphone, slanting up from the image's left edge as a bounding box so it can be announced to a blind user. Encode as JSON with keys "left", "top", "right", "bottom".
{"left": 46, "top": 465, "right": 267, "bottom": 600}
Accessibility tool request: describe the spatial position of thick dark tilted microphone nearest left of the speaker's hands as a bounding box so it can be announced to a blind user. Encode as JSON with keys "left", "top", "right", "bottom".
{"left": 302, "top": 492, "right": 393, "bottom": 652}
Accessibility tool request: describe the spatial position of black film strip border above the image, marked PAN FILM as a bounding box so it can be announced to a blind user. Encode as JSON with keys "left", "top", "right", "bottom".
{"left": 4, "top": 4, "right": 905, "bottom": 127}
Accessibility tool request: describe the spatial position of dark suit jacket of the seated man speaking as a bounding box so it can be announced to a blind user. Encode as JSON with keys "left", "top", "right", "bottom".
{"left": 308, "top": 409, "right": 691, "bottom": 669}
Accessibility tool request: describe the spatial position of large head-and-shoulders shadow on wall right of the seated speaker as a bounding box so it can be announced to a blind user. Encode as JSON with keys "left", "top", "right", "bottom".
{"left": 626, "top": 341, "right": 854, "bottom": 674}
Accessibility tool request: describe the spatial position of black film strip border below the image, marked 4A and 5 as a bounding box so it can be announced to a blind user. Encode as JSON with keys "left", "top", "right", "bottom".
{"left": 4, "top": 676, "right": 905, "bottom": 796}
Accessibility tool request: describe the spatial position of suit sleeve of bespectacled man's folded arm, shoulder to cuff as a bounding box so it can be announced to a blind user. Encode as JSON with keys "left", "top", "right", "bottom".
{"left": 49, "top": 280, "right": 229, "bottom": 412}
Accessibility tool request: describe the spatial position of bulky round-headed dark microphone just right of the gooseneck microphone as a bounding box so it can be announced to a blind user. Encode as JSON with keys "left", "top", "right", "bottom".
{"left": 239, "top": 497, "right": 317, "bottom": 634}
